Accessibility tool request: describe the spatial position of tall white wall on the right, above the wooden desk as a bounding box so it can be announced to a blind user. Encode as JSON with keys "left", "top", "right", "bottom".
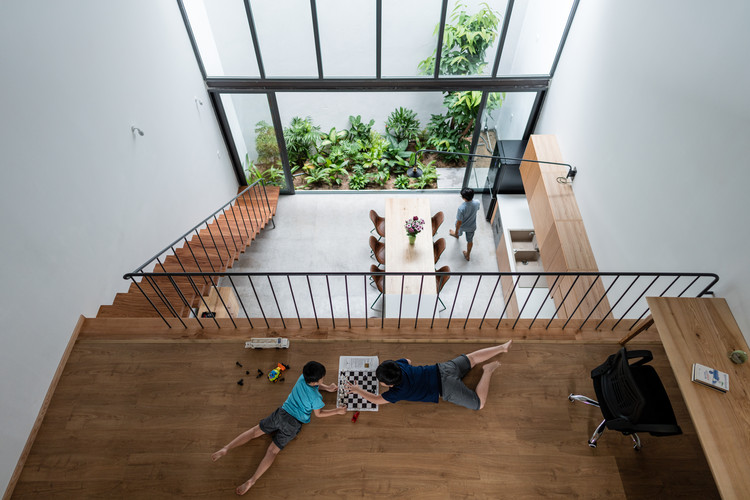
{"left": 536, "top": 0, "right": 750, "bottom": 337}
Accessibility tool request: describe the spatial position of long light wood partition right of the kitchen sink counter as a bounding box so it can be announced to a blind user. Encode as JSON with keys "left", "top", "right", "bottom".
{"left": 521, "top": 135, "right": 609, "bottom": 319}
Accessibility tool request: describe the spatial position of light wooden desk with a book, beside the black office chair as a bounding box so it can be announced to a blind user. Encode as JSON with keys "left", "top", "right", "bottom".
{"left": 646, "top": 297, "right": 750, "bottom": 499}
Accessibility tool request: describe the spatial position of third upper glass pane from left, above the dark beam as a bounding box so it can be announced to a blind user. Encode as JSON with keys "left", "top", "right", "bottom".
{"left": 316, "top": 0, "right": 376, "bottom": 78}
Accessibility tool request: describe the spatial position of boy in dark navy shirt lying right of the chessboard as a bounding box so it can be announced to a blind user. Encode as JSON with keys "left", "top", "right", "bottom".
{"left": 346, "top": 340, "right": 513, "bottom": 410}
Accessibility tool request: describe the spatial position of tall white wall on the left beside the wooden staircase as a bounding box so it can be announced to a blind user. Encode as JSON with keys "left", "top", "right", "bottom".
{"left": 0, "top": 0, "right": 237, "bottom": 490}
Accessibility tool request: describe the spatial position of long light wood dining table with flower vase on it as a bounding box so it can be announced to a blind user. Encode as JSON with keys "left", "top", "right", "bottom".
{"left": 385, "top": 197, "right": 437, "bottom": 317}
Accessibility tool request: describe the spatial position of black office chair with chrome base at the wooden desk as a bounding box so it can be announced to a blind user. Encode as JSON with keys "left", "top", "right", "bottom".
{"left": 568, "top": 347, "right": 682, "bottom": 450}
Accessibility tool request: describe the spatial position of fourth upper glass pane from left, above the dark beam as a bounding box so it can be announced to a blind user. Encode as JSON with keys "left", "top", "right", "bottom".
{"left": 380, "top": 0, "right": 443, "bottom": 78}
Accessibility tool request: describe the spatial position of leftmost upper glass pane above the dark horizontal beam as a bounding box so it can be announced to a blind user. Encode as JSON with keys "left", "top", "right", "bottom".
{"left": 183, "top": 0, "right": 260, "bottom": 78}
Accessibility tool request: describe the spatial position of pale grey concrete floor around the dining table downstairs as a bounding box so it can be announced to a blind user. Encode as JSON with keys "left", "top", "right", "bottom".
{"left": 221, "top": 191, "right": 503, "bottom": 318}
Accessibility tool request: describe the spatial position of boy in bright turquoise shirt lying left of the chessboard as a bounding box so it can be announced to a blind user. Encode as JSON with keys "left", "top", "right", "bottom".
{"left": 211, "top": 361, "right": 346, "bottom": 495}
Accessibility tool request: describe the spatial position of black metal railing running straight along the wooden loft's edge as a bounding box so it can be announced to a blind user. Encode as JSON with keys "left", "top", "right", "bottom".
{"left": 125, "top": 272, "right": 719, "bottom": 331}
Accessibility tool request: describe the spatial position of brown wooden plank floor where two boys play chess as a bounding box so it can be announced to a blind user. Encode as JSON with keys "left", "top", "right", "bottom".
{"left": 12, "top": 329, "right": 718, "bottom": 499}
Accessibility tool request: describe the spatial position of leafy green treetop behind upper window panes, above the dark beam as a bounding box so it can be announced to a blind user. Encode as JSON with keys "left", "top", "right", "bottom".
{"left": 418, "top": 2, "right": 500, "bottom": 75}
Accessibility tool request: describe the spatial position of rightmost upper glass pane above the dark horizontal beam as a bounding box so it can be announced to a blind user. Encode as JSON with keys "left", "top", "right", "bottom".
{"left": 497, "top": 0, "right": 573, "bottom": 76}
